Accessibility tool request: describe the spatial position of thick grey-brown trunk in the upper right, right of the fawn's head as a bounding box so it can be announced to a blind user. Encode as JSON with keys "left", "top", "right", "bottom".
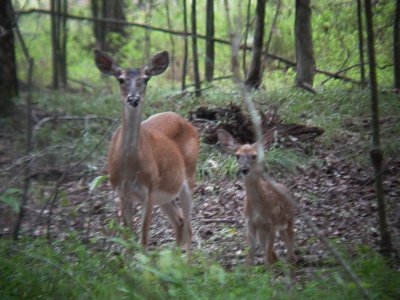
{"left": 295, "top": 0, "right": 315, "bottom": 87}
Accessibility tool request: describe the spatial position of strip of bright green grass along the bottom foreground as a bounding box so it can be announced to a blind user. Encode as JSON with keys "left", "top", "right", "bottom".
{"left": 0, "top": 238, "right": 400, "bottom": 299}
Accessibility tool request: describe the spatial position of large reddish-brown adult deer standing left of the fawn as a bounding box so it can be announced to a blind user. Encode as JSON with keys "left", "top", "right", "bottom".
{"left": 94, "top": 50, "right": 199, "bottom": 257}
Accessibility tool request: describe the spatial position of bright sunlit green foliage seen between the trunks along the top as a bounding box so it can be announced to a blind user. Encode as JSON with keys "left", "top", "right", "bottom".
{"left": 14, "top": 0, "right": 395, "bottom": 89}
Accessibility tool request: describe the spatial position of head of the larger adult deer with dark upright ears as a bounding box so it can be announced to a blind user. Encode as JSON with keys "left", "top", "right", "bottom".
{"left": 94, "top": 49, "right": 169, "bottom": 108}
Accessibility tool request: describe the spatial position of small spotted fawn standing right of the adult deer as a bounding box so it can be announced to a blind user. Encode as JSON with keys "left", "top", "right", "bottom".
{"left": 217, "top": 129, "right": 296, "bottom": 265}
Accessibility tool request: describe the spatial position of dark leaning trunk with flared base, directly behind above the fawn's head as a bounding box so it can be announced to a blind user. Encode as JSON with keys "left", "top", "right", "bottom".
{"left": 245, "top": 0, "right": 266, "bottom": 89}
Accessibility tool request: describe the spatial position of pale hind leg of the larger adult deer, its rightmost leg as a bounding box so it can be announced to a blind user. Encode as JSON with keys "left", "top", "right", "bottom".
{"left": 179, "top": 182, "right": 193, "bottom": 260}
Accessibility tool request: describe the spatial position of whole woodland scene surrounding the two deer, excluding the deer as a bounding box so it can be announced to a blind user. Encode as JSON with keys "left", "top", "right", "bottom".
{"left": 0, "top": 0, "right": 400, "bottom": 299}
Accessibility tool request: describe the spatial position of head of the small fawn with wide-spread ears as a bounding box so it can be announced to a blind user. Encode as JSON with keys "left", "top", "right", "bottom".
{"left": 217, "top": 129, "right": 275, "bottom": 176}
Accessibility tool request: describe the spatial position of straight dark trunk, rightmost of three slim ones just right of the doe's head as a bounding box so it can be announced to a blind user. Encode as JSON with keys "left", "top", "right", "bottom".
{"left": 205, "top": 0, "right": 215, "bottom": 81}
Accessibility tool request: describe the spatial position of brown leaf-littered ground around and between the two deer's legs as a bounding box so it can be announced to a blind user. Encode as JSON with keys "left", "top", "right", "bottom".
{"left": 0, "top": 102, "right": 400, "bottom": 269}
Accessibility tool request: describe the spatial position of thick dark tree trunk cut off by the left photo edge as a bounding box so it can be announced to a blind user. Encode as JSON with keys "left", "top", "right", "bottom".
{"left": 0, "top": 0, "right": 18, "bottom": 115}
